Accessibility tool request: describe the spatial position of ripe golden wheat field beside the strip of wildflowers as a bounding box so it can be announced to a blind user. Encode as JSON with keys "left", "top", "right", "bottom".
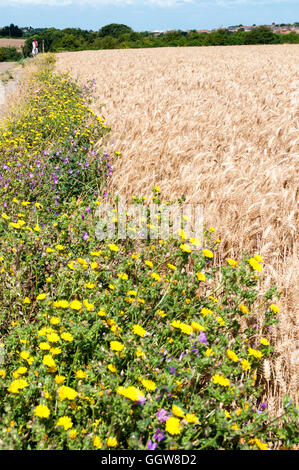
{"left": 56, "top": 45, "right": 299, "bottom": 414}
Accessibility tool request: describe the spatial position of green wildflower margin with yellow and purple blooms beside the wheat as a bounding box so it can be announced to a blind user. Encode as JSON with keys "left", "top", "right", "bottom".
{"left": 0, "top": 55, "right": 298, "bottom": 450}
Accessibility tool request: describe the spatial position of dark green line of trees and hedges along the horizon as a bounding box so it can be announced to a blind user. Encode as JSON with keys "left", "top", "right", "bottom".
{"left": 0, "top": 23, "right": 299, "bottom": 61}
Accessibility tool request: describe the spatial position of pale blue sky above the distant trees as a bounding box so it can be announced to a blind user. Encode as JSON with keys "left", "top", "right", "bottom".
{"left": 0, "top": 0, "right": 299, "bottom": 31}
